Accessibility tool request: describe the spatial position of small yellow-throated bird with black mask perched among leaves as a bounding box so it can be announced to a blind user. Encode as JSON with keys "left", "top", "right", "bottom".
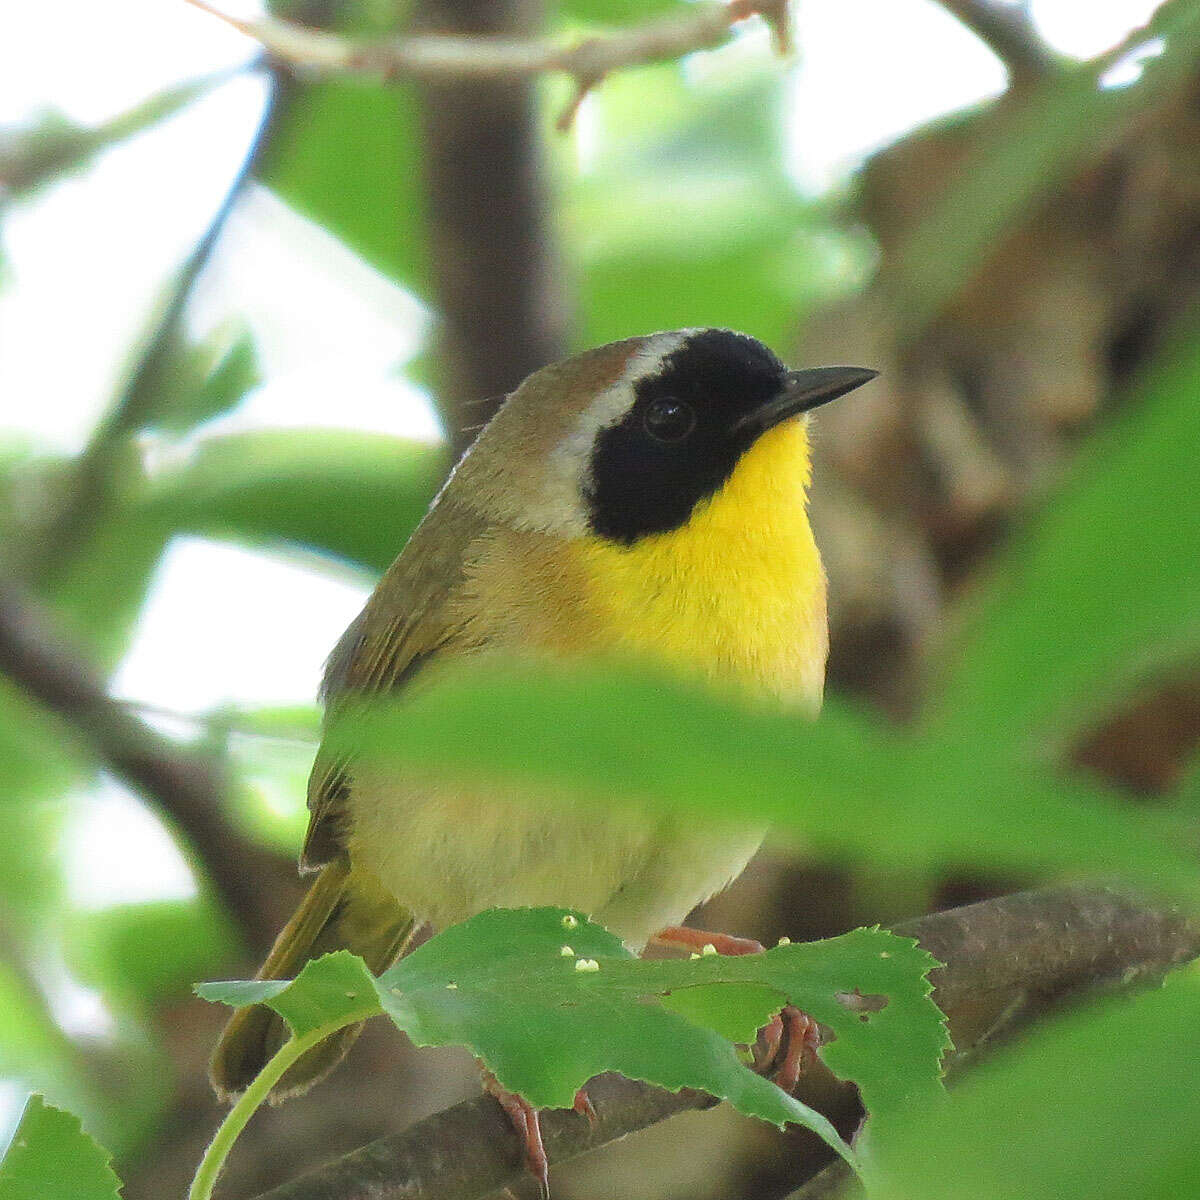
{"left": 210, "top": 328, "right": 876, "bottom": 1190}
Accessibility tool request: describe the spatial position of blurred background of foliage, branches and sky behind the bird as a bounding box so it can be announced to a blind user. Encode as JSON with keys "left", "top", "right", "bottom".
{"left": 0, "top": 0, "right": 1200, "bottom": 1200}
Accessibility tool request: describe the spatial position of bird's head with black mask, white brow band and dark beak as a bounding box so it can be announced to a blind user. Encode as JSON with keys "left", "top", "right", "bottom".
{"left": 455, "top": 329, "right": 875, "bottom": 546}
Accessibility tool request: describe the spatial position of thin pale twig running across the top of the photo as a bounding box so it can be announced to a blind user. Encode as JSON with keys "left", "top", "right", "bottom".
{"left": 188, "top": 0, "right": 788, "bottom": 128}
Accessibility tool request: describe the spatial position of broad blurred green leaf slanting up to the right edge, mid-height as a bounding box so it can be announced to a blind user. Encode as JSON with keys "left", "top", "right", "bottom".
{"left": 924, "top": 314, "right": 1200, "bottom": 756}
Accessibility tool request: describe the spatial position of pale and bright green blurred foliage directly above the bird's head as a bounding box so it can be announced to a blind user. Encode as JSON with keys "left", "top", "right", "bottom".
{"left": 560, "top": 54, "right": 866, "bottom": 346}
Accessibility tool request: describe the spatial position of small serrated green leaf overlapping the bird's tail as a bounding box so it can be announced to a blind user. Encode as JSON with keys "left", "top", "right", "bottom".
{"left": 196, "top": 950, "right": 382, "bottom": 1037}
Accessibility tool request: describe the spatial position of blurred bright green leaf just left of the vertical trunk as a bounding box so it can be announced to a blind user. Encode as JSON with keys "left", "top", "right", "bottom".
{"left": 259, "top": 79, "right": 428, "bottom": 290}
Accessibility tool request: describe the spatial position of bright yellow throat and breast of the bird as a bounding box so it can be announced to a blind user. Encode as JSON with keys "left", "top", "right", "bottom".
{"left": 574, "top": 420, "right": 828, "bottom": 709}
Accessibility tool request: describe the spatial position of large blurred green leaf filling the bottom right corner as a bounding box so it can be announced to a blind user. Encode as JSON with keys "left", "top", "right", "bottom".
{"left": 871, "top": 967, "right": 1200, "bottom": 1200}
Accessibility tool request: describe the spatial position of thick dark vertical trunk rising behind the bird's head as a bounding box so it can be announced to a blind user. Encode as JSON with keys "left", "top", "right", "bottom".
{"left": 413, "top": 0, "right": 569, "bottom": 455}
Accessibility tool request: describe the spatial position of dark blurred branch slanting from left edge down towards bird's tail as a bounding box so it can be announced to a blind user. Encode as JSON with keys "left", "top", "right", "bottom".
{"left": 0, "top": 581, "right": 291, "bottom": 949}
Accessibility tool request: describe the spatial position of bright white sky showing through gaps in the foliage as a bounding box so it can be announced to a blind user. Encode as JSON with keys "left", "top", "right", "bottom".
{"left": 0, "top": 0, "right": 1156, "bottom": 1041}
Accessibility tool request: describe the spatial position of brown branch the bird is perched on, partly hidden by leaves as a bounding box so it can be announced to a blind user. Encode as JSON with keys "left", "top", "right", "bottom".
{"left": 246, "top": 888, "right": 1200, "bottom": 1200}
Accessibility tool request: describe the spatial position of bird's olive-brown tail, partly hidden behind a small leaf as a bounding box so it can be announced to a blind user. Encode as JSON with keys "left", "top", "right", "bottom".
{"left": 209, "top": 859, "right": 414, "bottom": 1103}
